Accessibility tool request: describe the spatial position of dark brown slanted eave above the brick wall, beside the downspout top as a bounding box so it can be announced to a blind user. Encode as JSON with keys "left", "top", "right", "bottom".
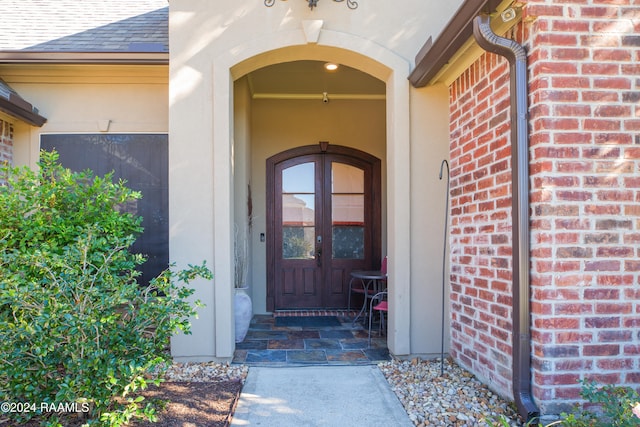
{"left": 409, "top": 0, "right": 501, "bottom": 87}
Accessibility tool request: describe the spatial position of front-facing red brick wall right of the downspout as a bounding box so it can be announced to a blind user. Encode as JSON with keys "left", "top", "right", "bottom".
{"left": 525, "top": 0, "right": 640, "bottom": 412}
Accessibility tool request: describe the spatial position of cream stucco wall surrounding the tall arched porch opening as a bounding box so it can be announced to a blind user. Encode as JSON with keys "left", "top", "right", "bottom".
{"left": 169, "top": 0, "right": 461, "bottom": 359}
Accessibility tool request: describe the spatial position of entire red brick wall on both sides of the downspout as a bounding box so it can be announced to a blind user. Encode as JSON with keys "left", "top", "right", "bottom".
{"left": 450, "top": 0, "right": 640, "bottom": 413}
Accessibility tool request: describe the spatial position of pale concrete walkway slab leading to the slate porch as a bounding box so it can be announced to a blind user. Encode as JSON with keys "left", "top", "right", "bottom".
{"left": 231, "top": 365, "right": 413, "bottom": 427}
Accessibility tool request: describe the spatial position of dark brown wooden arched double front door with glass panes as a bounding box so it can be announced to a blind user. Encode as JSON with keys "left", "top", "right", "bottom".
{"left": 267, "top": 146, "right": 380, "bottom": 310}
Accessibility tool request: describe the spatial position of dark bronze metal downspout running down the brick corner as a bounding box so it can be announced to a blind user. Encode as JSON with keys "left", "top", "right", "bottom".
{"left": 473, "top": 16, "right": 540, "bottom": 421}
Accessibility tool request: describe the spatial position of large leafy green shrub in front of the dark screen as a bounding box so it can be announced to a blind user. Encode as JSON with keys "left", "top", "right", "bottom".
{"left": 0, "top": 152, "right": 211, "bottom": 426}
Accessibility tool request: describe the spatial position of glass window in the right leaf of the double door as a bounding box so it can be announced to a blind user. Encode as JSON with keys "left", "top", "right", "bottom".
{"left": 331, "top": 163, "right": 365, "bottom": 259}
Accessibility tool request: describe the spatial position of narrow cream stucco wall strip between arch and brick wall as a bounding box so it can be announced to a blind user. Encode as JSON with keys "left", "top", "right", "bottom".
{"left": 410, "top": 85, "right": 449, "bottom": 356}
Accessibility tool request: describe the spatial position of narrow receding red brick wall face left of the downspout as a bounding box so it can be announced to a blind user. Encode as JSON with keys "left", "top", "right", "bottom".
{"left": 450, "top": 54, "right": 511, "bottom": 402}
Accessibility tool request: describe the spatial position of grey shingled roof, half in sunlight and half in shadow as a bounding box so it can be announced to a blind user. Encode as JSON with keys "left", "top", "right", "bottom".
{"left": 0, "top": 0, "right": 169, "bottom": 52}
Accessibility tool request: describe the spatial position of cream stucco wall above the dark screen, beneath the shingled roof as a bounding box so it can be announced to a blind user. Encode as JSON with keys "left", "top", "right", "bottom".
{"left": 0, "top": 65, "right": 169, "bottom": 166}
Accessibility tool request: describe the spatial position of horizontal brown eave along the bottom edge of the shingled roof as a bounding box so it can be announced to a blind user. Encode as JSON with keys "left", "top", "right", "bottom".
{"left": 0, "top": 50, "right": 169, "bottom": 65}
